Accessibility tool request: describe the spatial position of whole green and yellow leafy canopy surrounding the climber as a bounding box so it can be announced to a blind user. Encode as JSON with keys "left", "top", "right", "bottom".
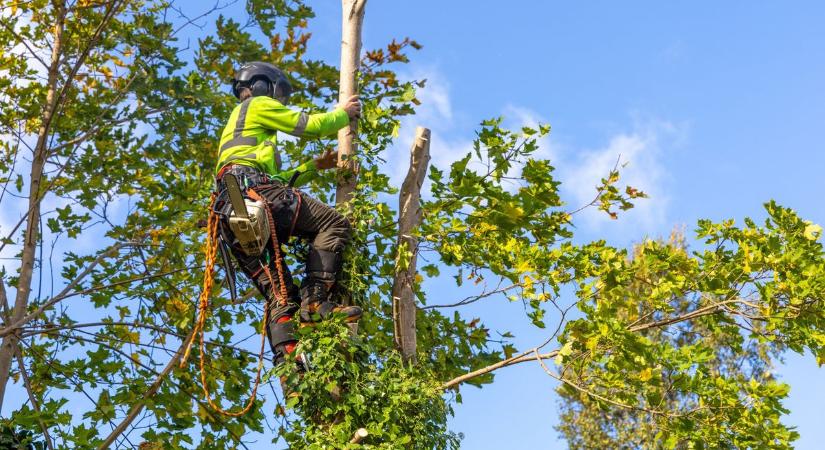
{"left": 0, "top": 0, "right": 825, "bottom": 449}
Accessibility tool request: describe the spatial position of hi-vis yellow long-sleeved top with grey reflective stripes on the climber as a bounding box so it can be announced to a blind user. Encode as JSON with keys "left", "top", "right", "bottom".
{"left": 215, "top": 96, "right": 349, "bottom": 185}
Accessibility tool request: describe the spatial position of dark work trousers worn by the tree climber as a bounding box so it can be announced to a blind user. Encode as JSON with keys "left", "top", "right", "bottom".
{"left": 232, "top": 182, "right": 351, "bottom": 323}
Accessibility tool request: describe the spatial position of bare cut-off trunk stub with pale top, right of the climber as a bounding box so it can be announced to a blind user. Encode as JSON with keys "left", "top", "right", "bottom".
{"left": 392, "top": 127, "right": 430, "bottom": 363}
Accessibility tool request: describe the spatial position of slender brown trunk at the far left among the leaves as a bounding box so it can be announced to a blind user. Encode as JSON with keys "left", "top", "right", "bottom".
{"left": 0, "top": 2, "right": 66, "bottom": 411}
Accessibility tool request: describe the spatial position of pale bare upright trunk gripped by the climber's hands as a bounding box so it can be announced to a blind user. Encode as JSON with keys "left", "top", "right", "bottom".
{"left": 335, "top": 0, "right": 367, "bottom": 205}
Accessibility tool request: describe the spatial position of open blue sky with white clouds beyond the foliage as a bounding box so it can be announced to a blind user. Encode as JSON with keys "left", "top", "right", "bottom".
{"left": 6, "top": 0, "right": 825, "bottom": 449}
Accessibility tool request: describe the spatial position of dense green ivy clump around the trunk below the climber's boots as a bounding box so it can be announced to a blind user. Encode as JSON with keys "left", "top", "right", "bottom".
{"left": 273, "top": 321, "right": 459, "bottom": 449}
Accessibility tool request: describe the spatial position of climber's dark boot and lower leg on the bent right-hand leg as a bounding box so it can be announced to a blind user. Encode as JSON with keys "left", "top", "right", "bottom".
{"left": 301, "top": 247, "right": 363, "bottom": 322}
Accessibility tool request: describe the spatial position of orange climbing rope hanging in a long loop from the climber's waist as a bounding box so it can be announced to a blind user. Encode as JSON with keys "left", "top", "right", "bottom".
{"left": 180, "top": 189, "right": 287, "bottom": 417}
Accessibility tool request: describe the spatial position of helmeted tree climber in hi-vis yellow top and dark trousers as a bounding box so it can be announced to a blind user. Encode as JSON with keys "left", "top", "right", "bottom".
{"left": 214, "top": 62, "right": 362, "bottom": 372}
